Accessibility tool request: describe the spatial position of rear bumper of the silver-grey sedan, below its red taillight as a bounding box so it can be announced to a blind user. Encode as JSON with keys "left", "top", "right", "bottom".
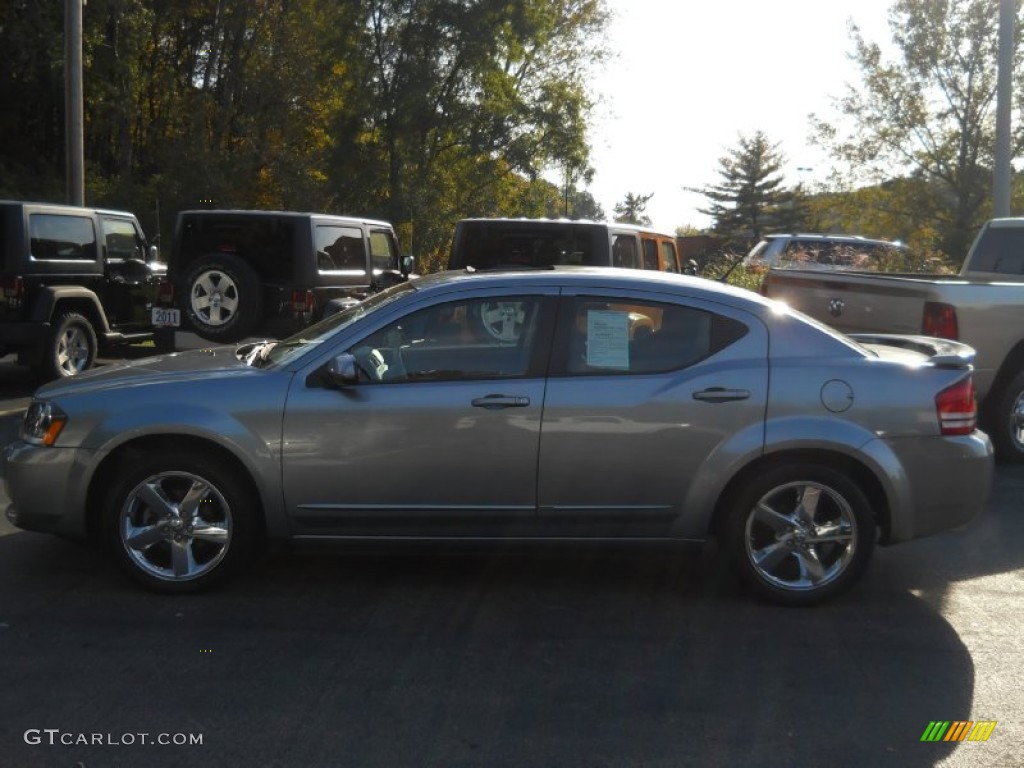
{"left": 879, "top": 431, "right": 994, "bottom": 544}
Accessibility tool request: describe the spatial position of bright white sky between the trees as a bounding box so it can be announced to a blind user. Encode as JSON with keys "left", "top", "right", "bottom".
{"left": 590, "top": 0, "right": 892, "bottom": 231}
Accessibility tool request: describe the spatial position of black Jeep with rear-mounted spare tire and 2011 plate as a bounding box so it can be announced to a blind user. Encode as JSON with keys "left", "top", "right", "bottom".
{"left": 161, "top": 210, "right": 413, "bottom": 342}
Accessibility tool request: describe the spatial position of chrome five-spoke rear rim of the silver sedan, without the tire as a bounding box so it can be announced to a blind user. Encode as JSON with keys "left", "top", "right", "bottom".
{"left": 743, "top": 481, "right": 858, "bottom": 592}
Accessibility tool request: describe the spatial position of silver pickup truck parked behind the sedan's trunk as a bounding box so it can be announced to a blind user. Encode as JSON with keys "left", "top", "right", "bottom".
{"left": 761, "top": 218, "right": 1024, "bottom": 462}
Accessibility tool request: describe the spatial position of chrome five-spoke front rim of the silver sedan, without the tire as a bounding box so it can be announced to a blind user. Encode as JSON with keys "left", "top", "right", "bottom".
{"left": 118, "top": 471, "right": 232, "bottom": 582}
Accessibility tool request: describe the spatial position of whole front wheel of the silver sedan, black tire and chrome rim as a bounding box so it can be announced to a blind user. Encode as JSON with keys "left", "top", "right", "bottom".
{"left": 102, "top": 452, "right": 259, "bottom": 594}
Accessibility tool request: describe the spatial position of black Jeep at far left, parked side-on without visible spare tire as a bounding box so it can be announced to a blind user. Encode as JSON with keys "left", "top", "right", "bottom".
{"left": 0, "top": 201, "right": 165, "bottom": 379}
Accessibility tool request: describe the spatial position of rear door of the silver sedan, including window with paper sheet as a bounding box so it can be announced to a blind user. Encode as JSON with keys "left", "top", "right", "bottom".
{"left": 538, "top": 293, "right": 768, "bottom": 538}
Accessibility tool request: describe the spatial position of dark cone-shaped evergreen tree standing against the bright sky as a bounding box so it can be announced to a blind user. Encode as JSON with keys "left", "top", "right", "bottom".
{"left": 691, "top": 131, "right": 804, "bottom": 242}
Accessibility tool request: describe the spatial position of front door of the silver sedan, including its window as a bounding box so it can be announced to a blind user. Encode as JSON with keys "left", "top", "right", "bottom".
{"left": 282, "top": 289, "right": 555, "bottom": 537}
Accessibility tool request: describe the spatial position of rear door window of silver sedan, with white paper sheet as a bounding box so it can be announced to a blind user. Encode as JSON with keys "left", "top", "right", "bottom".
{"left": 566, "top": 297, "right": 748, "bottom": 374}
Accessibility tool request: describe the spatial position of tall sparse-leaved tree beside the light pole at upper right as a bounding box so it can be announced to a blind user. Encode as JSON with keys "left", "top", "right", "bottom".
{"left": 812, "top": 0, "right": 1021, "bottom": 259}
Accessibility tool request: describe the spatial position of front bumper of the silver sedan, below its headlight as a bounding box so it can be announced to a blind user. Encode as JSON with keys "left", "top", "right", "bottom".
{"left": 3, "top": 440, "right": 95, "bottom": 539}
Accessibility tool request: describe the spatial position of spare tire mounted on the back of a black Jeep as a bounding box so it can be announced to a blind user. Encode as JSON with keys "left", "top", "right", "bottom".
{"left": 182, "top": 253, "right": 263, "bottom": 342}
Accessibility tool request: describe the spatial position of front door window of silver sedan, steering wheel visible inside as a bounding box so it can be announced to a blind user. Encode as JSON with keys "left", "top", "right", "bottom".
{"left": 349, "top": 297, "right": 542, "bottom": 383}
